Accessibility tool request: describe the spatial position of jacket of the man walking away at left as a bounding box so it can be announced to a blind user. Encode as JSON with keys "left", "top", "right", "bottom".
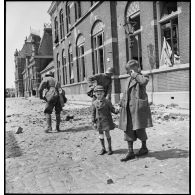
{"left": 38, "top": 76, "right": 61, "bottom": 103}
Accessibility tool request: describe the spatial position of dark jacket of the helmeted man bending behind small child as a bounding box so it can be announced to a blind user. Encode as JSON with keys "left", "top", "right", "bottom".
{"left": 88, "top": 73, "right": 112, "bottom": 99}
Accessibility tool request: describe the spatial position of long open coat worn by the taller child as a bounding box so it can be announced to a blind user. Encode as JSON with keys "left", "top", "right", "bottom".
{"left": 119, "top": 73, "right": 153, "bottom": 131}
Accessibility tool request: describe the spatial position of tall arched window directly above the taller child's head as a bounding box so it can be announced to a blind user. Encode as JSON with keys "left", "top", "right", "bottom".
{"left": 126, "top": 1, "right": 143, "bottom": 69}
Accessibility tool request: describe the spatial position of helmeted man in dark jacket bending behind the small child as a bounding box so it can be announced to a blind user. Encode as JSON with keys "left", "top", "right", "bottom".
{"left": 87, "top": 67, "right": 114, "bottom": 101}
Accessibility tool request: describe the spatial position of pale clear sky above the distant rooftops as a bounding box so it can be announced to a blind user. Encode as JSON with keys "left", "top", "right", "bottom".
{"left": 5, "top": 1, "right": 52, "bottom": 88}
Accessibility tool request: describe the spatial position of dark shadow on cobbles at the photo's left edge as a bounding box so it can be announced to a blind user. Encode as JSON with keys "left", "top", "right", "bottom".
{"left": 5, "top": 131, "right": 22, "bottom": 158}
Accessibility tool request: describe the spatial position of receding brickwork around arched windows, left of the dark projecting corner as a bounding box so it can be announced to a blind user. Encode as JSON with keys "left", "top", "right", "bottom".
{"left": 52, "top": 1, "right": 113, "bottom": 86}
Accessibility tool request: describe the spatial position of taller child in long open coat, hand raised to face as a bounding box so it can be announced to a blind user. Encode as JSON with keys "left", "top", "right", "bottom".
{"left": 119, "top": 60, "right": 153, "bottom": 161}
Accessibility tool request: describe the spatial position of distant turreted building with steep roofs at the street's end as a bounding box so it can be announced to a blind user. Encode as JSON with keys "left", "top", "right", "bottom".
{"left": 15, "top": 24, "right": 53, "bottom": 97}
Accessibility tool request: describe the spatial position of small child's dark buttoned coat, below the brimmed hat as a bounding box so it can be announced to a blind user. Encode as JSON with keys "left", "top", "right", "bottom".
{"left": 92, "top": 98, "right": 118, "bottom": 130}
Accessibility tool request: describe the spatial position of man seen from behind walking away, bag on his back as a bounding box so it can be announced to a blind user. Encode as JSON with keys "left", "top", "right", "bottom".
{"left": 39, "top": 71, "right": 62, "bottom": 133}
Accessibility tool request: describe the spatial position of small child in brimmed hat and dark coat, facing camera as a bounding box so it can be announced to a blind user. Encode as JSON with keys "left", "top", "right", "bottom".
{"left": 92, "top": 85, "right": 119, "bottom": 155}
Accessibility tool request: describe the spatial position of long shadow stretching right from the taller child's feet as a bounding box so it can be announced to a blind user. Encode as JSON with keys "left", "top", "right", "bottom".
{"left": 114, "top": 149, "right": 189, "bottom": 160}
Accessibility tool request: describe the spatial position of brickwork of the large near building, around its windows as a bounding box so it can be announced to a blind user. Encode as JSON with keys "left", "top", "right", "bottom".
{"left": 48, "top": 1, "right": 189, "bottom": 103}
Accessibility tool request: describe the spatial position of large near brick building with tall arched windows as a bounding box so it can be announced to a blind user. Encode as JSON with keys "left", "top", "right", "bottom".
{"left": 48, "top": 1, "right": 190, "bottom": 107}
